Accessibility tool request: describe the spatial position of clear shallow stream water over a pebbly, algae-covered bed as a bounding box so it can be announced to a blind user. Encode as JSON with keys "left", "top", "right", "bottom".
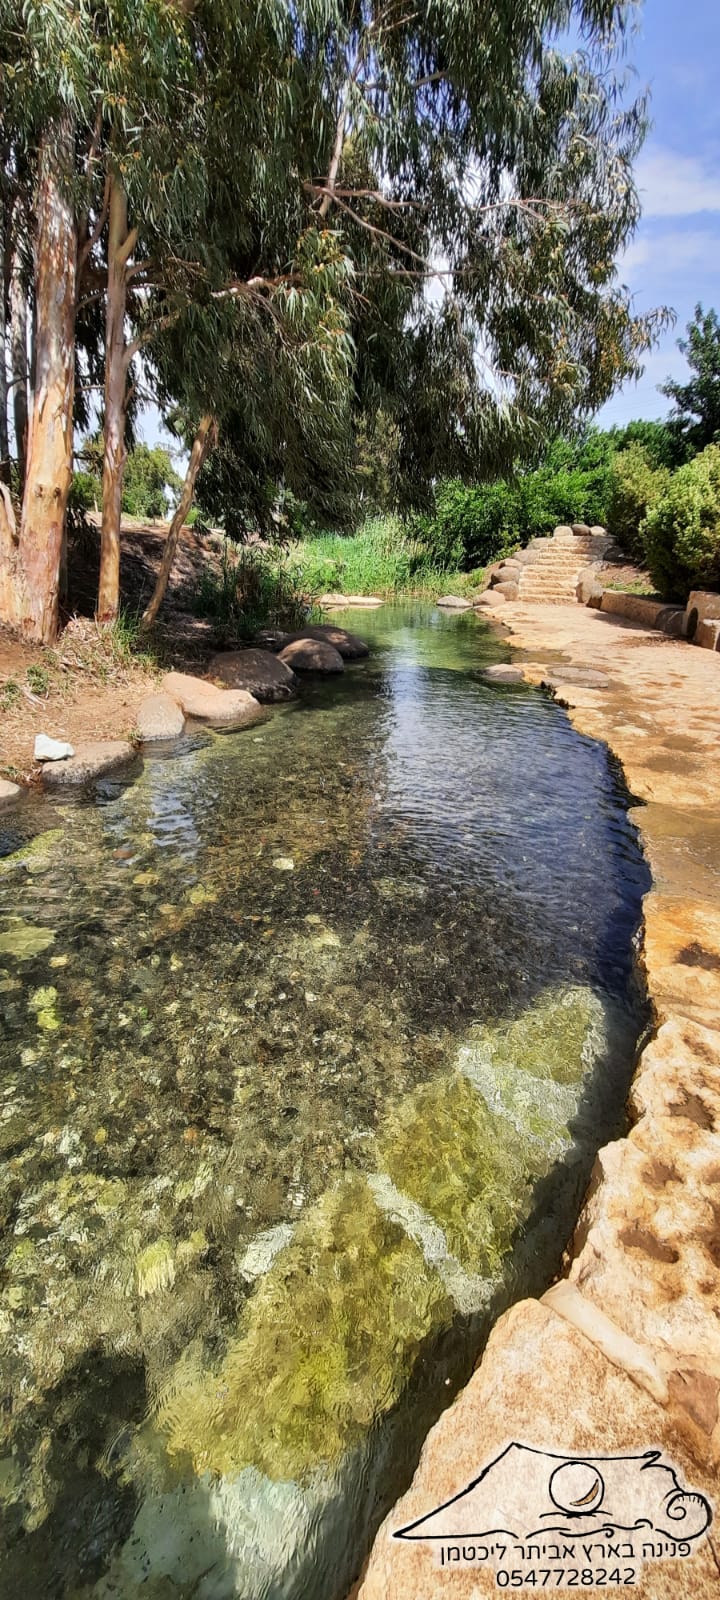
{"left": 0, "top": 606, "right": 648, "bottom": 1600}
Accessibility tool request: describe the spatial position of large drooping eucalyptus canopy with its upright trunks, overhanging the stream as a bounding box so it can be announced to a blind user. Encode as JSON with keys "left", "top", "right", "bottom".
{"left": 0, "top": 0, "right": 659, "bottom": 637}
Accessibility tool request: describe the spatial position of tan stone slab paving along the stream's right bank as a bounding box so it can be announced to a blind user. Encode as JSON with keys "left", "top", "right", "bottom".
{"left": 357, "top": 603, "right": 720, "bottom": 1600}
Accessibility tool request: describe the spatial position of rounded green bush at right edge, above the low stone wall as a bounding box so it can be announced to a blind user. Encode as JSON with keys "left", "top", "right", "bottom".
{"left": 642, "top": 445, "right": 720, "bottom": 602}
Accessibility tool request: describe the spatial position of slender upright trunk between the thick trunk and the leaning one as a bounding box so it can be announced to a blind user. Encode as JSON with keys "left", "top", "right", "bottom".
{"left": 98, "top": 174, "right": 134, "bottom": 622}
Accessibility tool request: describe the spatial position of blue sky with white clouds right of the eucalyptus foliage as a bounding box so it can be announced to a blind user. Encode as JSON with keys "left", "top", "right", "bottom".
{"left": 598, "top": 0, "right": 720, "bottom": 424}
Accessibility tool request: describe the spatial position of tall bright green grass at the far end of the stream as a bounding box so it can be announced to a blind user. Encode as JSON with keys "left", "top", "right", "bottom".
{"left": 290, "top": 517, "right": 478, "bottom": 595}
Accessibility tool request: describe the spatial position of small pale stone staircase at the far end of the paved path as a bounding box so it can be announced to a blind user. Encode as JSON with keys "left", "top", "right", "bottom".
{"left": 493, "top": 523, "right": 611, "bottom": 605}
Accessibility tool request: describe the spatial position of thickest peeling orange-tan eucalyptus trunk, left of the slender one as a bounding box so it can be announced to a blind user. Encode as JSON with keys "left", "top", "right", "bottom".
{"left": 18, "top": 114, "right": 77, "bottom": 645}
